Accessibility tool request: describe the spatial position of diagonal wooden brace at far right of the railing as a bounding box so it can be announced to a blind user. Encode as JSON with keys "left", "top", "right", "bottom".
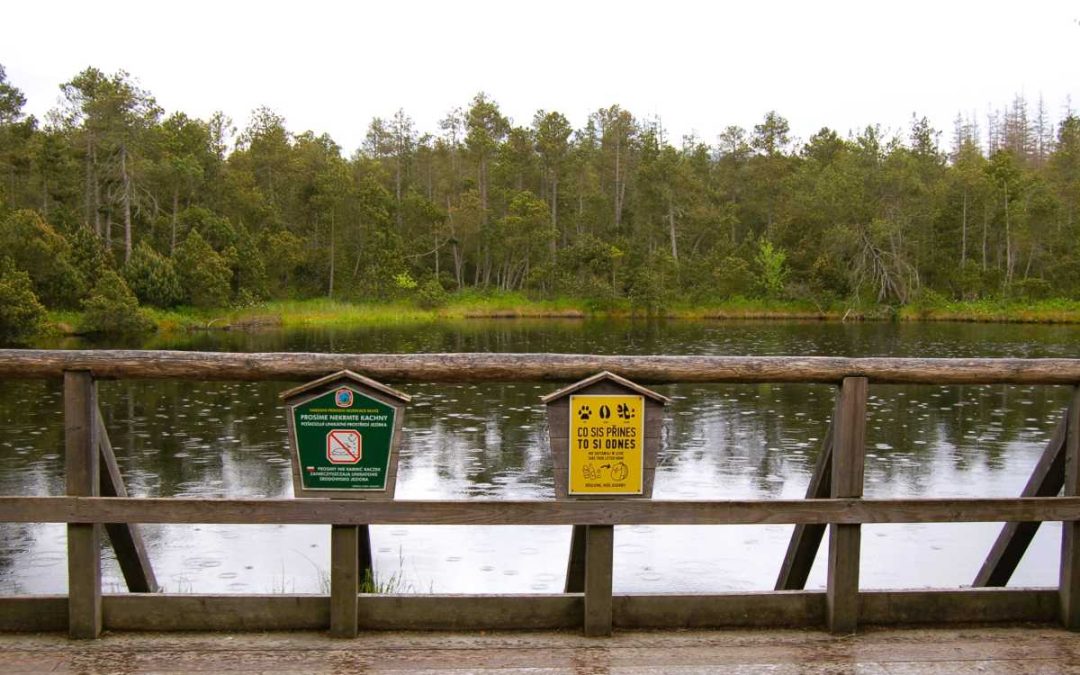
{"left": 971, "top": 408, "right": 1069, "bottom": 586}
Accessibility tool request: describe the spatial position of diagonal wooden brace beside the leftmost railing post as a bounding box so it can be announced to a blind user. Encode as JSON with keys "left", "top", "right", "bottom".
{"left": 94, "top": 409, "right": 160, "bottom": 593}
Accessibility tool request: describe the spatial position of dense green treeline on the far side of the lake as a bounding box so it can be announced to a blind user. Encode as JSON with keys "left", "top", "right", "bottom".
{"left": 0, "top": 68, "right": 1080, "bottom": 336}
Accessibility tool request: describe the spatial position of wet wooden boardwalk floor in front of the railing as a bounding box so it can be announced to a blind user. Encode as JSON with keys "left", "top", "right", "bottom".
{"left": 0, "top": 625, "right": 1080, "bottom": 675}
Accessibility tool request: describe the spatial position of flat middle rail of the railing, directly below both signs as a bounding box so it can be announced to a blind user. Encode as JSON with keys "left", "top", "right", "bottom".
{"left": 0, "top": 497, "right": 1080, "bottom": 525}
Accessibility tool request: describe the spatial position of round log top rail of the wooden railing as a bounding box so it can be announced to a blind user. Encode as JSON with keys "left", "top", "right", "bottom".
{"left": 6, "top": 349, "right": 1080, "bottom": 384}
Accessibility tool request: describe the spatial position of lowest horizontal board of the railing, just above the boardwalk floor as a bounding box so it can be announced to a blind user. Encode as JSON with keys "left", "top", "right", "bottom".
{"left": 0, "top": 589, "right": 1059, "bottom": 635}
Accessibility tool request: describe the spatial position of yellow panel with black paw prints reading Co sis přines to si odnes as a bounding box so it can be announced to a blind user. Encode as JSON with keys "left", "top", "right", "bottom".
{"left": 569, "top": 388, "right": 645, "bottom": 495}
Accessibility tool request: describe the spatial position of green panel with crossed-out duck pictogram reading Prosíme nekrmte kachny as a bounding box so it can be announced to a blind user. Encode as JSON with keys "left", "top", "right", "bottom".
{"left": 288, "top": 383, "right": 397, "bottom": 491}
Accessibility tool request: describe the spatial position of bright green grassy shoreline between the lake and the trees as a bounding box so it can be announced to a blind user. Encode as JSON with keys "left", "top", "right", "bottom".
{"left": 50, "top": 294, "right": 1080, "bottom": 334}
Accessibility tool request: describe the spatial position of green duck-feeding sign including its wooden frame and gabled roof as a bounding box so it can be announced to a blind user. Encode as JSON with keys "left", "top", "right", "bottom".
{"left": 281, "top": 370, "right": 410, "bottom": 500}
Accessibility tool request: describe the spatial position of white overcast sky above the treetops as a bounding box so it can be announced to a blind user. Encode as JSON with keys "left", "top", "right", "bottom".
{"left": 0, "top": 0, "right": 1080, "bottom": 153}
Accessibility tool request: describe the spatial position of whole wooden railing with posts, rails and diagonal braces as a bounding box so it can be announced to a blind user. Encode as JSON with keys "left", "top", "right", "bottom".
{"left": 0, "top": 350, "right": 1080, "bottom": 637}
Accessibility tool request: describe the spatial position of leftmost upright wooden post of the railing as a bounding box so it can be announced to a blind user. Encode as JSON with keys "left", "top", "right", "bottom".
{"left": 64, "top": 370, "right": 102, "bottom": 638}
